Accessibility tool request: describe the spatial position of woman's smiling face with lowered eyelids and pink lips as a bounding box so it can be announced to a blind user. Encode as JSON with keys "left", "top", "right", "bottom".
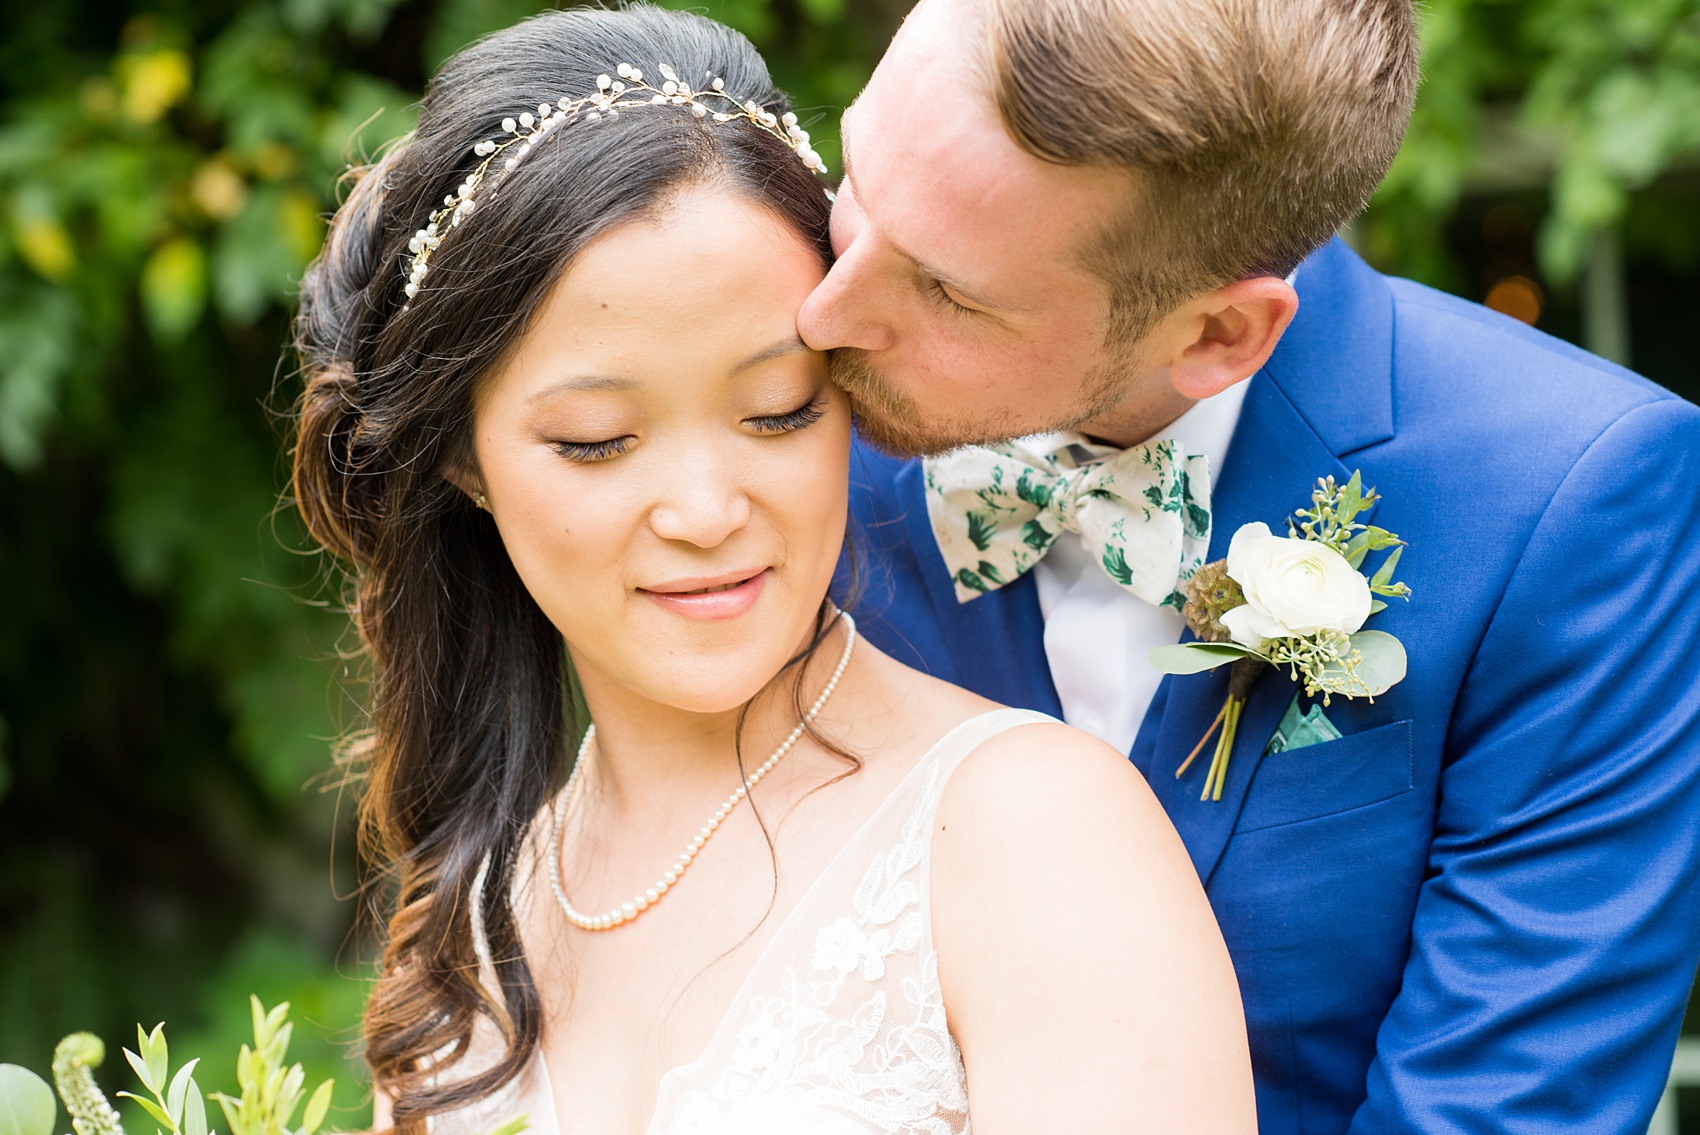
{"left": 471, "top": 181, "right": 850, "bottom": 712}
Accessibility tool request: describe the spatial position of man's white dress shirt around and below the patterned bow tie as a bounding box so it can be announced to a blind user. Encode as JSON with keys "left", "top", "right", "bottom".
{"left": 1023, "top": 382, "right": 1246, "bottom": 753}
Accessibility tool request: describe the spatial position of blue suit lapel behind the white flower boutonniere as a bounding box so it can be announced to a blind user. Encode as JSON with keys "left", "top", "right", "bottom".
{"left": 1131, "top": 241, "right": 1392, "bottom": 884}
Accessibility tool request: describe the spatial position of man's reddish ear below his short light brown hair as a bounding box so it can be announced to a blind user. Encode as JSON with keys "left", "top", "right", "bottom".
{"left": 1166, "top": 275, "right": 1299, "bottom": 401}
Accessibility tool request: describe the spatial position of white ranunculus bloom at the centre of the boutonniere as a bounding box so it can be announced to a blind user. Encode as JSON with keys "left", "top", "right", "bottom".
{"left": 1222, "top": 523, "right": 1370, "bottom": 651}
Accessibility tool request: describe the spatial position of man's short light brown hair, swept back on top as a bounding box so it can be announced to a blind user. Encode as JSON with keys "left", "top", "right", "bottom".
{"left": 986, "top": 0, "right": 1418, "bottom": 340}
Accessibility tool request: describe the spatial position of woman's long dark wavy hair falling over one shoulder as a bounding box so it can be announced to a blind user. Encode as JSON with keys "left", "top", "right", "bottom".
{"left": 294, "top": 7, "right": 831, "bottom": 1133}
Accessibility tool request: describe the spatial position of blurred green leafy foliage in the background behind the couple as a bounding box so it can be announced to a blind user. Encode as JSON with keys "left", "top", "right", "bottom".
{"left": 0, "top": 0, "right": 1700, "bottom": 1132}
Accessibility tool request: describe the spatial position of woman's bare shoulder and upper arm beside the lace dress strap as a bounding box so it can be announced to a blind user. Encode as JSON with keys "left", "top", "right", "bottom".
{"left": 930, "top": 722, "right": 1256, "bottom": 1135}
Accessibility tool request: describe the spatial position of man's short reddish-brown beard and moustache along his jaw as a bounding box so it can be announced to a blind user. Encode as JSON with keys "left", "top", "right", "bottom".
{"left": 826, "top": 347, "right": 1127, "bottom": 457}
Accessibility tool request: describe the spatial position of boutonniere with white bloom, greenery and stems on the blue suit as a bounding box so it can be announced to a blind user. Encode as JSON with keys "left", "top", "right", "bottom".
{"left": 1151, "top": 472, "right": 1411, "bottom": 800}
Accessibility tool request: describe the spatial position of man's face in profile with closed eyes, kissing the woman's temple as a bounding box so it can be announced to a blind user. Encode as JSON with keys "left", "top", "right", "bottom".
{"left": 799, "top": 0, "right": 1166, "bottom": 452}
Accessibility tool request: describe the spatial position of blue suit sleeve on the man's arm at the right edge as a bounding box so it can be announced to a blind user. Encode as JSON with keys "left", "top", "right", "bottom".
{"left": 1350, "top": 399, "right": 1700, "bottom": 1135}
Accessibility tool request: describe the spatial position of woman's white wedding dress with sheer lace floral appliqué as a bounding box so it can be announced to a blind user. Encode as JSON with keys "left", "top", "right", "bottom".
{"left": 430, "top": 709, "right": 1054, "bottom": 1135}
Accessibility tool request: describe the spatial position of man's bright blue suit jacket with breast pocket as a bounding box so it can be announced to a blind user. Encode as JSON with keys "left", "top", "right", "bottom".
{"left": 852, "top": 241, "right": 1700, "bottom": 1135}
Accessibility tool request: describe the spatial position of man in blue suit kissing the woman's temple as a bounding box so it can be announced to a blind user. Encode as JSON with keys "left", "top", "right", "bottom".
{"left": 801, "top": 0, "right": 1700, "bottom": 1135}
